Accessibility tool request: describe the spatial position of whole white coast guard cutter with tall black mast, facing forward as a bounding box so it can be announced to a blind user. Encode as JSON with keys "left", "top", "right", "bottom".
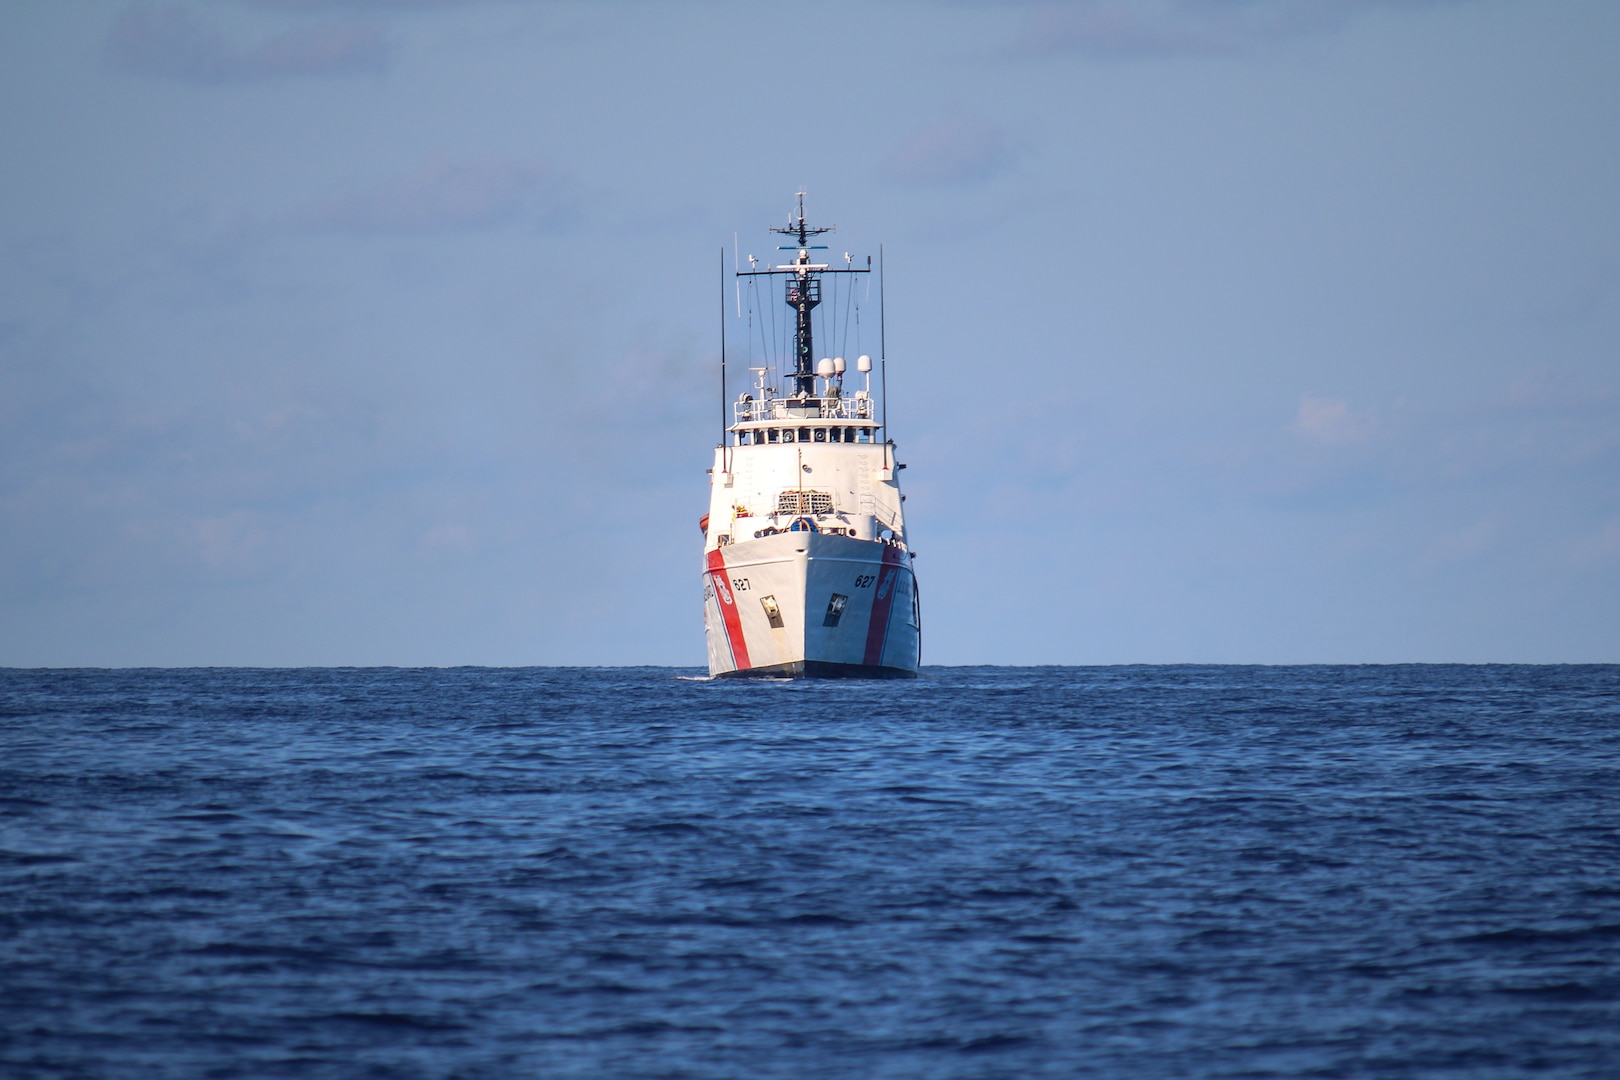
{"left": 700, "top": 193, "right": 922, "bottom": 678}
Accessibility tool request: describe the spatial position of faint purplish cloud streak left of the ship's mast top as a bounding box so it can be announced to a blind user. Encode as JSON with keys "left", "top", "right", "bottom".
{"left": 301, "top": 160, "right": 572, "bottom": 233}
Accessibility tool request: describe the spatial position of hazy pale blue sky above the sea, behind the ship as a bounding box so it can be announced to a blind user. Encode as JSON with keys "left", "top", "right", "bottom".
{"left": 0, "top": 0, "right": 1620, "bottom": 665}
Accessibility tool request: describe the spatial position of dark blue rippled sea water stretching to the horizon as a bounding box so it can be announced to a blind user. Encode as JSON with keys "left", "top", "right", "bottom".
{"left": 0, "top": 667, "right": 1620, "bottom": 1080}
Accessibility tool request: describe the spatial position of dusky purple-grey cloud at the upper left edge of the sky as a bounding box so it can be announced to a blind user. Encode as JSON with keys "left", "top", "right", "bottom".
{"left": 105, "top": 3, "right": 389, "bottom": 83}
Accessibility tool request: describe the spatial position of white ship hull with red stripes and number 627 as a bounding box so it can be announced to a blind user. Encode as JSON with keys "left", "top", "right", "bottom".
{"left": 703, "top": 533, "right": 922, "bottom": 678}
